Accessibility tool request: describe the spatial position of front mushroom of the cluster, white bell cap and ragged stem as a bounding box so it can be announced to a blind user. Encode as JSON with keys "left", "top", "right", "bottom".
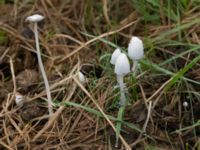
{"left": 115, "top": 53, "right": 130, "bottom": 105}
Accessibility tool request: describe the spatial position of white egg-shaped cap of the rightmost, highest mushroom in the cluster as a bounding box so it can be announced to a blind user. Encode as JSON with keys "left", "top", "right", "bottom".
{"left": 128, "top": 36, "right": 144, "bottom": 60}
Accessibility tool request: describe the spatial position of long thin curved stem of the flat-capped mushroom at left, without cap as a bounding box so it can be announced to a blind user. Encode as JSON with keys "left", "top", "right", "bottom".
{"left": 34, "top": 23, "right": 53, "bottom": 115}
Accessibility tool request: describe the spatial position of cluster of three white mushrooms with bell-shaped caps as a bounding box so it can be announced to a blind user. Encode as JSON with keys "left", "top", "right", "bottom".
{"left": 110, "top": 36, "right": 144, "bottom": 105}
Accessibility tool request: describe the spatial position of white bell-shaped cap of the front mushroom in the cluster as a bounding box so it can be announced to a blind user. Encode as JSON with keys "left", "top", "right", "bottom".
{"left": 115, "top": 53, "right": 130, "bottom": 75}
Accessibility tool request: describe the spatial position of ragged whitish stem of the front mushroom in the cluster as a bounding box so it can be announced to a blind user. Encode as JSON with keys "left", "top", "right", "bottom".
{"left": 117, "top": 75, "right": 126, "bottom": 106}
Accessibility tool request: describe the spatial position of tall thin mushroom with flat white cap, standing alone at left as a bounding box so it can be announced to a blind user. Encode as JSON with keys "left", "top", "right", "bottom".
{"left": 26, "top": 14, "right": 53, "bottom": 115}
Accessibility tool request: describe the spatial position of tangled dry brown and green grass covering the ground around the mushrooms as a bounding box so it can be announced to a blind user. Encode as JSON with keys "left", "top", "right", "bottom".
{"left": 0, "top": 0, "right": 200, "bottom": 150}
